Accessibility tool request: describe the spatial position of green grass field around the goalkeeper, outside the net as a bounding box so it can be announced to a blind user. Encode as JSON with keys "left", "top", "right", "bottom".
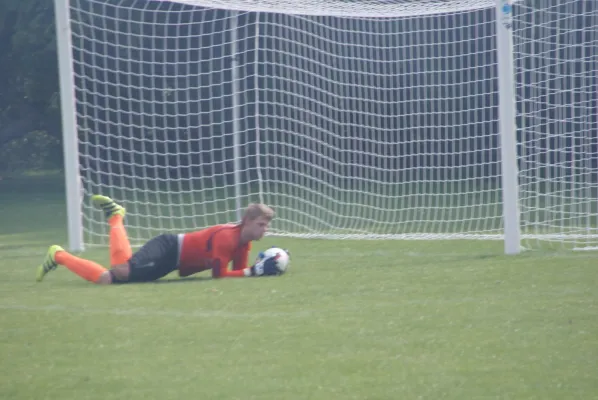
{"left": 0, "top": 178, "right": 598, "bottom": 400}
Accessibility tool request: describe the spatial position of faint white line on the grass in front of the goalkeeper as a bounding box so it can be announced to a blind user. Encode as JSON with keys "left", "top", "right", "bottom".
{"left": 0, "top": 304, "right": 311, "bottom": 319}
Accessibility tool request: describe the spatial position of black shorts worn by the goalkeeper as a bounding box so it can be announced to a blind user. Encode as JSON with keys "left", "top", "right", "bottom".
{"left": 119, "top": 234, "right": 179, "bottom": 282}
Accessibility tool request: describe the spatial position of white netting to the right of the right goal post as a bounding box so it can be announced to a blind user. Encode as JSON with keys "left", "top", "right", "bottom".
{"left": 514, "top": 0, "right": 598, "bottom": 250}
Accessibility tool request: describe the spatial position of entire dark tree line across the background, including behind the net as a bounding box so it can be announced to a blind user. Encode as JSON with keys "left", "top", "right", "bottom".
{"left": 0, "top": 0, "right": 598, "bottom": 186}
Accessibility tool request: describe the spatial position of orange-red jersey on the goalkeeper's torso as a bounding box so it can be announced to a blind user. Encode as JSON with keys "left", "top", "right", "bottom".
{"left": 179, "top": 224, "right": 251, "bottom": 278}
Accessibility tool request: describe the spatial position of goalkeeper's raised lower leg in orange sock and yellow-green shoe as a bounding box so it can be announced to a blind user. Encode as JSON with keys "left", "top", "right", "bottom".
{"left": 91, "top": 194, "right": 133, "bottom": 268}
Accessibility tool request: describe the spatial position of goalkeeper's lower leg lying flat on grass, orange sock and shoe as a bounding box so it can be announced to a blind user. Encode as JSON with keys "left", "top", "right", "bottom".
{"left": 37, "top": 245, "right": 111, "bottom": 284}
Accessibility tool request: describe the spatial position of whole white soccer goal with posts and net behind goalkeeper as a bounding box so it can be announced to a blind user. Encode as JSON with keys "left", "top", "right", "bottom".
{"left": 54, "top": 0, "right": 598, "bottom": 254}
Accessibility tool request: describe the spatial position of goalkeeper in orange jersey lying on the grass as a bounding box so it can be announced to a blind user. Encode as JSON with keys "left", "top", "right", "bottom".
{"left": 37, "top": 195, "right": 279, "bottom": 284}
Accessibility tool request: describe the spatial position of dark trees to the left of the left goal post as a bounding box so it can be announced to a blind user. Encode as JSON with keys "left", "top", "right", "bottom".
{"left": 0, "top": 0, "right": 62, "bottom": 174}
